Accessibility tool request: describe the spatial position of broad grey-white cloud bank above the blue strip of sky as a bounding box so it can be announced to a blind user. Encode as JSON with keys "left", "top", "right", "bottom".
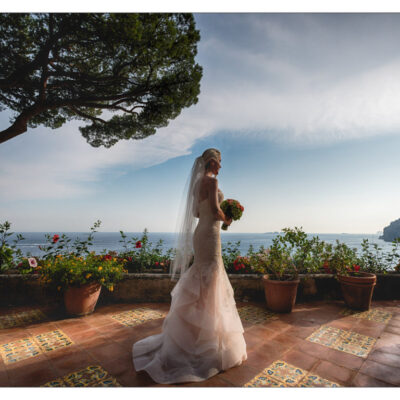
{"left": 0, "top": 14, "right": 400, "bottom": 201}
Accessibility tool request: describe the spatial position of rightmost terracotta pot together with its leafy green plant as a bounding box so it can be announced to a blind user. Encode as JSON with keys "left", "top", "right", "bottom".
{"left": 330, "top": 241, "right": 376, "bottom": 310}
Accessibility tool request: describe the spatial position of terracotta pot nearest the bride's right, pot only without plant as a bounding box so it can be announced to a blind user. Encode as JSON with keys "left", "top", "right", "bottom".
{"left": 262, "top": 275, "right": 300, "bottom": 313}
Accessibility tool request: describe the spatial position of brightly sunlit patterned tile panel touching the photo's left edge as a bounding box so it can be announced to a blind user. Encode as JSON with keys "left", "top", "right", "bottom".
{"left": 0, "top": 330, "right": 73, "bottom": 364}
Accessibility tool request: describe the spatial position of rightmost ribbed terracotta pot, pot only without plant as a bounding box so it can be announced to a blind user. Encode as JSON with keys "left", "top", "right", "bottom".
{"left": 338, "top": 272, "right": 376, "bottom": 310}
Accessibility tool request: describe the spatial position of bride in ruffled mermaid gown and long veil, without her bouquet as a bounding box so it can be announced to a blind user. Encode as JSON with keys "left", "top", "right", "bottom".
{"left": 133, "top": 149, "right": 247, "bottom": 384}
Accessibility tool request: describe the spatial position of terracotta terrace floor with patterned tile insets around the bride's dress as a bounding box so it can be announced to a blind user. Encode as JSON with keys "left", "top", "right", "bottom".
{"left": 0, "top": 300, "right": 400, "bottom": 387}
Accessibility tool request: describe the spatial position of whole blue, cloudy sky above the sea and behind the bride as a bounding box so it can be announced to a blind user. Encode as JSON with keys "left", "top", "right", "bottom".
{"left": 0, "top": 13, "right": 400, "bottom": 233}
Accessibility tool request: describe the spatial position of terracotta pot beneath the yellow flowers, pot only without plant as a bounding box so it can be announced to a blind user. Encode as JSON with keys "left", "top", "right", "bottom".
{"left": 64, "top": 282, "right": 101, "bottom": 316}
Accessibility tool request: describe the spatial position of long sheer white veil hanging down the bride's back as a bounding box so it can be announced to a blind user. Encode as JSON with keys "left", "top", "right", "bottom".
{"left": 170, "top": 156, "right": 205, "bottom": 280}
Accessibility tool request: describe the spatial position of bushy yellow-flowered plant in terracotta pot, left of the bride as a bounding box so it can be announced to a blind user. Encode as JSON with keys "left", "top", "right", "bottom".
{"left": 40, "top": 252, "right": 126, "bottom": 316}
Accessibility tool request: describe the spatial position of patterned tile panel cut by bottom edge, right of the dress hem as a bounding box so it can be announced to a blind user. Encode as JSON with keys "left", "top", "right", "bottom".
{"left": 244, "top": 360, "right": 340, "bottom": 387}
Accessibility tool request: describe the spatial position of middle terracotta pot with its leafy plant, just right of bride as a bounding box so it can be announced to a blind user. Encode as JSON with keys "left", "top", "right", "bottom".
{"left": 255, "top": 236, "right": 299, "bottom": 313}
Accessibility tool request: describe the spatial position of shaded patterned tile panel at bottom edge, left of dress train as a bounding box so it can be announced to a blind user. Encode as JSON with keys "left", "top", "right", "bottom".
{"left": 43, "top": 365, "right": 121, "bottom": 387}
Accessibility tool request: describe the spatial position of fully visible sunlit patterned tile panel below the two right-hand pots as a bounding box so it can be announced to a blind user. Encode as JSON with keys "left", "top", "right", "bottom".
{"left": 307, "top": 325, "right": 376, "bottom": 358}
